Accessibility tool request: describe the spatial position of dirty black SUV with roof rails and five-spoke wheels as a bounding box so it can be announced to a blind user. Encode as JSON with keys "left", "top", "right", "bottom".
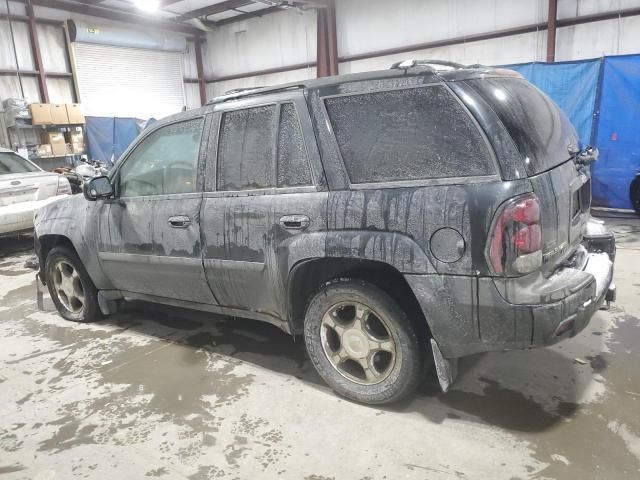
{"left": 35, "top": 61, "right": 615, "bottom": 403}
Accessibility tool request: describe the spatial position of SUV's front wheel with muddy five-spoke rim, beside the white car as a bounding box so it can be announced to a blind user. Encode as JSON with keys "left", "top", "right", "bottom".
{"left": 45, "top": 247, "right": 102, "bottom": 322}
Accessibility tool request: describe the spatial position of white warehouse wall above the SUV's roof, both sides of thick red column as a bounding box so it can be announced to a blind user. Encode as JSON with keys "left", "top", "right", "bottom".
{"left": 205, "top": 0, "right": 640, "bottom": 90}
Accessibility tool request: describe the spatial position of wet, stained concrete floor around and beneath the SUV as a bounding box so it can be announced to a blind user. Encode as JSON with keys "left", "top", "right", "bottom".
{"left": 0, "top": 219, "right": 640, "bottom": 480}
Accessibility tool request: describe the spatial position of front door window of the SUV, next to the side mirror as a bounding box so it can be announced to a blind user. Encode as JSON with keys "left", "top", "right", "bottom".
{"left": 119, "top": 118, "right": 203, "bottom": 197}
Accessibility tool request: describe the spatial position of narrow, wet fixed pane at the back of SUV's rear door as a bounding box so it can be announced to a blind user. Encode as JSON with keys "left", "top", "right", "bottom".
{"left": 277, "top": 103, "right": 311, "bottom": 187}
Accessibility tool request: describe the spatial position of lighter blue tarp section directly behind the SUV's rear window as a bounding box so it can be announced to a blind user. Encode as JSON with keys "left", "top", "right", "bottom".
{"left": 508, "top": 60, "right": 601, "bottom": 145}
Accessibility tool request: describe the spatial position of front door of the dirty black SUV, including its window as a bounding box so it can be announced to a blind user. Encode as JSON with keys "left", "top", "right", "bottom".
{"left": 100, "top": 118, "right": 215, "bottom": 303}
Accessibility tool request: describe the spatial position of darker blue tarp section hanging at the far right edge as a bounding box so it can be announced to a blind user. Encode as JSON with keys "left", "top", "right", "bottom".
{"left": 593, "top": 55, "right": 640, "bottom": 208}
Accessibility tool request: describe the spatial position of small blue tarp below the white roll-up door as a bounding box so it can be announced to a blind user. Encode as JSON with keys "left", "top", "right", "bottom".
{"left": 86, "top": 117, "right": 141, "bottom": 166}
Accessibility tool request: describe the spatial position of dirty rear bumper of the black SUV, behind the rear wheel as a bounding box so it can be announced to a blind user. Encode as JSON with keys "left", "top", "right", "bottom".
{"left": 405, "top": 225, "right": 615, "bottom": 358}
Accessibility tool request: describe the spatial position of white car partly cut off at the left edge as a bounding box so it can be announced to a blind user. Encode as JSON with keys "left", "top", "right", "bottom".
{"left": 0, "top": 148, "right": 71, "bottom": 235}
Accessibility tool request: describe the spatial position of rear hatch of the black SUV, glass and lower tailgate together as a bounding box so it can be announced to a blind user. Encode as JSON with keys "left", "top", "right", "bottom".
{"left": 467, "top": 77, "right": 591, "bottom": 270}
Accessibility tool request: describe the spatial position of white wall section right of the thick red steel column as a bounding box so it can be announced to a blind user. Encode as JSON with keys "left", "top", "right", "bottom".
{"left": 336, "top": 0, "right": 640, "bottom": 73}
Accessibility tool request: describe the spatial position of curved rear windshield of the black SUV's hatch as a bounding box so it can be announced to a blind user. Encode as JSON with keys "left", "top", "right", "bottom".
{"left": 468, "top": 78, "right": 578, "bottom": 175}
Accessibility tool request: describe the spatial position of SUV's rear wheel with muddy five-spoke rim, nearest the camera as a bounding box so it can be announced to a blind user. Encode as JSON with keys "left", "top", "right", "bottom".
{"left": 304, "top": 279, "right": 423, "bottom": 404}
